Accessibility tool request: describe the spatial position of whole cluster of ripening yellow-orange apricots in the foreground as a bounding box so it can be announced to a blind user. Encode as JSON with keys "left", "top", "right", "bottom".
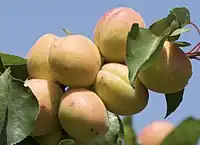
{"left": 25, "top": 7, "right": 192, "bottom": 145}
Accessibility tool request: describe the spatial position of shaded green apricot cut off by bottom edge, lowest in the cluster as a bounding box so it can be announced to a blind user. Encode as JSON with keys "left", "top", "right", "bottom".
{"left": 34, "top": 131, "right": 62, "bottom": 145}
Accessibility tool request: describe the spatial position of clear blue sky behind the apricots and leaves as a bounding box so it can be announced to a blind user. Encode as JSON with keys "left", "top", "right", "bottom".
{"left": 0, "top": 0, "right": 200, "bottom": 140}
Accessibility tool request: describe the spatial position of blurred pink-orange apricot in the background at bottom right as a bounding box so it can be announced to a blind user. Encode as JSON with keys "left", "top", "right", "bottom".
{"left": 138, "top": 120, "right": 175, "bottom": 145}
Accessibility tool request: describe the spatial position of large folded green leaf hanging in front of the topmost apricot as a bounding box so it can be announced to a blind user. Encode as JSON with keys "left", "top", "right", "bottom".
{"left": 126, "top": 24, "right": 173, "bottom": 85}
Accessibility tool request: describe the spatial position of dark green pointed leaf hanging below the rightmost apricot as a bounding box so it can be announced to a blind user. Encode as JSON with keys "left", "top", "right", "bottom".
{"left": 165, "top": 89, "right": 184, "bottom": 118}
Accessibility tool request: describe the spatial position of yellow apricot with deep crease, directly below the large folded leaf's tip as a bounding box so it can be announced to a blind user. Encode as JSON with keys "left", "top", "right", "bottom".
{"left": 94, "top": 63, "right": 149, "bottom": 115}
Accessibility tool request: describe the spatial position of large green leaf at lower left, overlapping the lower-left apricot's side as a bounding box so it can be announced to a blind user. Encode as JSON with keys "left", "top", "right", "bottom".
{"left": 7, "top": 80, "right": 39, "bottom": 145}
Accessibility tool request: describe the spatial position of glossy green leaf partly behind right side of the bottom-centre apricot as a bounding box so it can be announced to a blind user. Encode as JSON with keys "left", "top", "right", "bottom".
{"left": 90, "top": 111, "right": 122, "bottom": 145}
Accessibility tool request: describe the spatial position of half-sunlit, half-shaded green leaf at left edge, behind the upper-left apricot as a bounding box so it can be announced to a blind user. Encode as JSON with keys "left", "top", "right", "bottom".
{"left": 0, "top": 53, "right": 28, "bottom": 81}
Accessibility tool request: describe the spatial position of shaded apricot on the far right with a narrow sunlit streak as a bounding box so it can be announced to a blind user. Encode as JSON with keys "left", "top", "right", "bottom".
{"left": 138, "top": 41, "right": 192, "bottom": 93}
